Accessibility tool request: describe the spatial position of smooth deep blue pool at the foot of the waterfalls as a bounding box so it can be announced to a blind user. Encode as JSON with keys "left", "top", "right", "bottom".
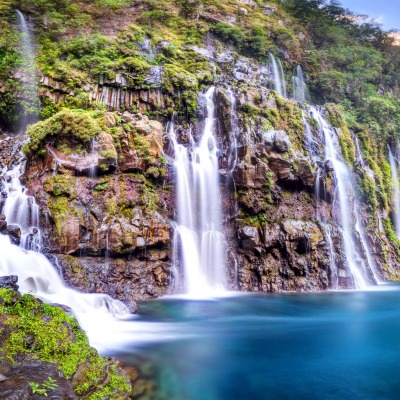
{"left": 108, "top": 287, "right": 400, "bottom": 400}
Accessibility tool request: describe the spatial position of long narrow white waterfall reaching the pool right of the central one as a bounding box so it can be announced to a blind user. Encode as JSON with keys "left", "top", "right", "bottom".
{"left": 310, "top": 107, "right": 373, "bottom": 289}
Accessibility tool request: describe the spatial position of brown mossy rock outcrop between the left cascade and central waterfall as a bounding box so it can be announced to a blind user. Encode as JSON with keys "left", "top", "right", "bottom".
{"left": 19, "top": 112, "right": 173, "bottom": 310}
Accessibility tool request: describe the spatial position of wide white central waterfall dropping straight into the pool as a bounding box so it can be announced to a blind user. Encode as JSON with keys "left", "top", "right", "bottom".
{"left": 170, "top": 88, "right": 225, "bottom": 296}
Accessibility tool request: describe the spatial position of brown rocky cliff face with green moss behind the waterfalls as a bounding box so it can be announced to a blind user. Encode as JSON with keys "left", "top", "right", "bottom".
{"left": 1, "top": 1, "right": 400, "bottom": 304}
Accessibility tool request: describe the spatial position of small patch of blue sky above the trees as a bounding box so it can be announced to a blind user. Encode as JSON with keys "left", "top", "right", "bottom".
{"left": 339, "top": 0, "right": 400, "bottom": 31}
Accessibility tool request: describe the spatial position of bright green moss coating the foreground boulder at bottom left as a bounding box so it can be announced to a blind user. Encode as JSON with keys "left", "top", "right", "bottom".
{"left": 0, "top": 289, "right": 131, "bottom": 399}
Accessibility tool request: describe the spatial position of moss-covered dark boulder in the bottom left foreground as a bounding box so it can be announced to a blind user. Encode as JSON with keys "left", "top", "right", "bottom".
{"left": 0, "top": 289, "right": 132, "bottom": 400}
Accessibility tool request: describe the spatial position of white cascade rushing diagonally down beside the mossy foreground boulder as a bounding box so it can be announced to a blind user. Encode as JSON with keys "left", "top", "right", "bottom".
{"left": 0, "top": 164, "right": 129, "bottom": 346}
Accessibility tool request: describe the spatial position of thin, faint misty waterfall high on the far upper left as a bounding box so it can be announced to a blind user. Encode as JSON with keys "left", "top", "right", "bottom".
{"left": 16, "top": 10, "right": 39, "bottom": 133}
